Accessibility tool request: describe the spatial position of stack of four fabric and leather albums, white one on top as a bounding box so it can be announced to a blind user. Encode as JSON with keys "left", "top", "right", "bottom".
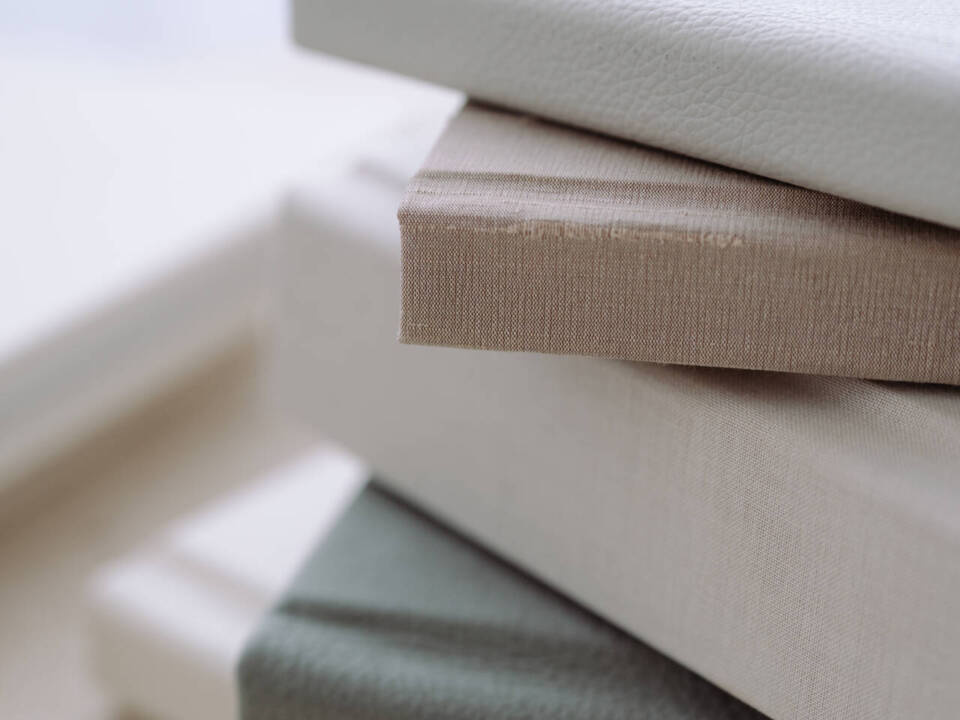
{"left": 240, "top": 0, "right": 960, "bottom": 720}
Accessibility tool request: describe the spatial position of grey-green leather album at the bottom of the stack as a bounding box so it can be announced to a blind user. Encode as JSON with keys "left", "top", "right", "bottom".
{"left": 238, "top": 485, "right": 764, "bottom": 720}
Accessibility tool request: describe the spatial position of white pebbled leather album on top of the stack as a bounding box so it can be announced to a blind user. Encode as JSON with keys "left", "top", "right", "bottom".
{"left": 293, "top": 0, "right": 960, "bottom": 227}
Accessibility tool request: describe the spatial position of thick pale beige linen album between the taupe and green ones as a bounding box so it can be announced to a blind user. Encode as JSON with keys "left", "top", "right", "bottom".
{"left": 276, "top": 138, "right": 960, "bottom": 720}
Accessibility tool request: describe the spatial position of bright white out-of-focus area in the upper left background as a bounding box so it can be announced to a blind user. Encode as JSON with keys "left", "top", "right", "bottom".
{"left": 0, "top": 0, "right": 428, "bottom": 357}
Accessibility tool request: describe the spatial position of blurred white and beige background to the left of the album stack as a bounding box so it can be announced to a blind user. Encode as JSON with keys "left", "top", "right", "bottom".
{"left": 0, "top": 0, "right": 452, "bottom": 720}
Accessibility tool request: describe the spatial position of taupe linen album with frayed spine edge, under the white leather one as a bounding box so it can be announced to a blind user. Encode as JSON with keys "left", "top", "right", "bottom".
{"left": 400, "top": 105, "right": 960, "bottom": 384}
